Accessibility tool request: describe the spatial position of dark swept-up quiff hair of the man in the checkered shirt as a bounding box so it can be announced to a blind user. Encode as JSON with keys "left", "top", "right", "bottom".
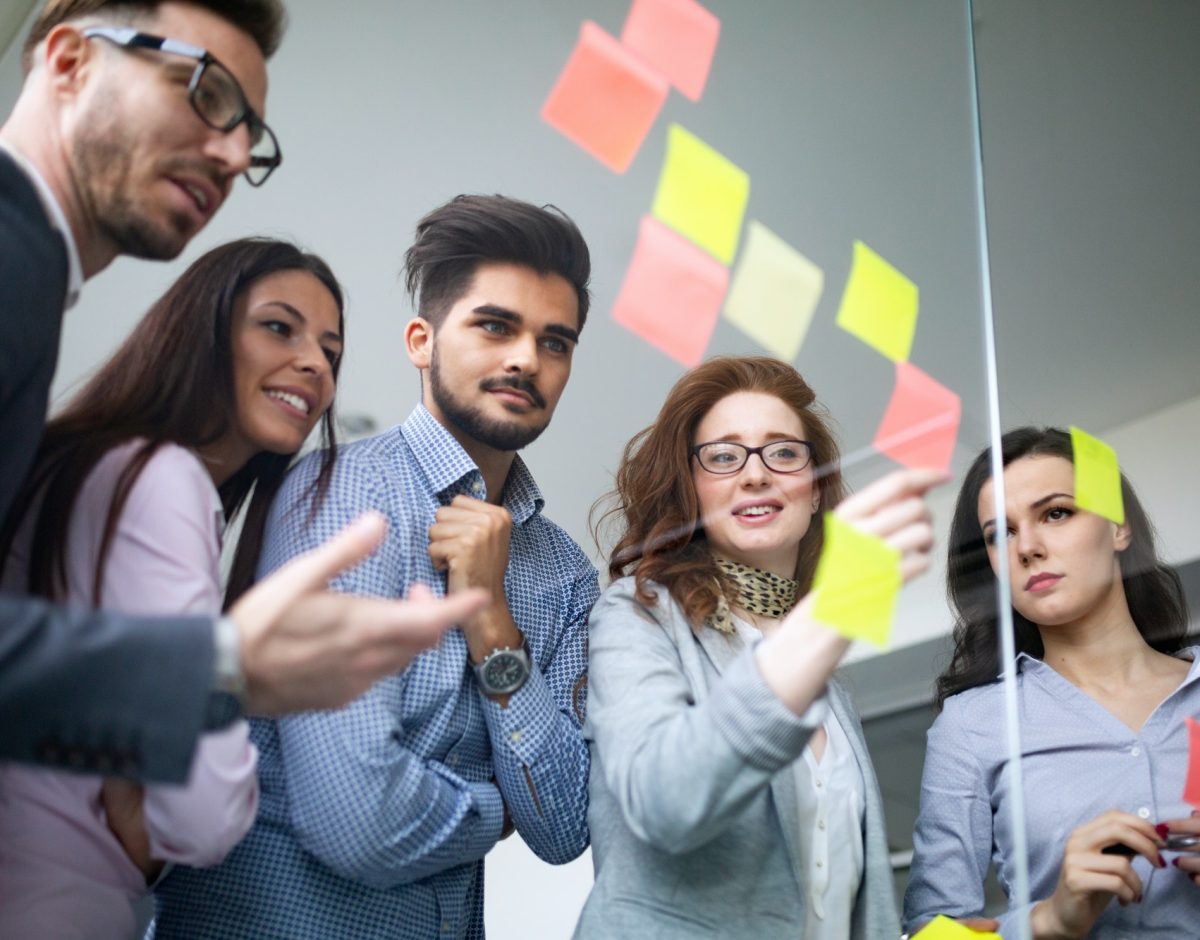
{"left": 404, "top": 196, "right": 592, "bottom": 330}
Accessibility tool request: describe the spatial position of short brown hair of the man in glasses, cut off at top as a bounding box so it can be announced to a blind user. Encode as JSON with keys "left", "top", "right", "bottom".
{"left": 20, "top": 0, "right": 287, "bottom": 74}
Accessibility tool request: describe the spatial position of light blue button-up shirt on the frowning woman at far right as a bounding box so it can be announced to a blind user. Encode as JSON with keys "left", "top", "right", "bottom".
{"left": 905, "top": 647, "right": 1200, "bottom": 940}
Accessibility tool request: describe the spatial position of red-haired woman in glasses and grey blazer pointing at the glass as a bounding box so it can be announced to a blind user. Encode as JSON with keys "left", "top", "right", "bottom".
{"left": 576, "top": 358, "right": 944, "bottom": 940}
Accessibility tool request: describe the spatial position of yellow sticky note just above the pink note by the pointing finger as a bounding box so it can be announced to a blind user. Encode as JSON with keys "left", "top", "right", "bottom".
{"left": 838, "top": 241, "right": 918, "bottom": 363}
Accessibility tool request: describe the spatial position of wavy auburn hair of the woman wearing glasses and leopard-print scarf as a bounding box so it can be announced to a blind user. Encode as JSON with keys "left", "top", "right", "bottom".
{"left": 595, "top": 357, "right": 846, "bottom": 629}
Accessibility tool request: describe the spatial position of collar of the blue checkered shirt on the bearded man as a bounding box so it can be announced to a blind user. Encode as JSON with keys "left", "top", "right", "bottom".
{"left": 400, "top": 405, "right": 546, "bottom": 526}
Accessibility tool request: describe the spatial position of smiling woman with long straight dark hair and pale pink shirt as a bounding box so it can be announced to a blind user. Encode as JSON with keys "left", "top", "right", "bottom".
{"left": 0, "top": 239, "right": 343, "bottom": 940}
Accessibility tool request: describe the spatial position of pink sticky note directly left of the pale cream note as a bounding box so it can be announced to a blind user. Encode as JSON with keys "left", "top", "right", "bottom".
{"left": 612, "top": 215, "right": 730, "bottom": 369}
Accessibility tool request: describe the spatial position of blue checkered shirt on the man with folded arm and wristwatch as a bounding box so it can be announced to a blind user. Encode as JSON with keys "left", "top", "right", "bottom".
{"left": 156, "top": 406, "right": 598, "bottom": 940}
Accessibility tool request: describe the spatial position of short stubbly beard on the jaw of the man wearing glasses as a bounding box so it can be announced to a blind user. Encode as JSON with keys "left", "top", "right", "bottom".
{"left": 72, "top": 104, "right": 192, "bottom": 261}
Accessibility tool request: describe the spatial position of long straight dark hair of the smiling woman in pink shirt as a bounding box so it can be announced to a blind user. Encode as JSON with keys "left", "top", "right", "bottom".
{"left": 0, "top": 238, "right": 344, "bottom": 605}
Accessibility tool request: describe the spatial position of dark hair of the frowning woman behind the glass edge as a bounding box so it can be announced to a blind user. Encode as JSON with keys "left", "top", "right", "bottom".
{"left": 935, "top": 427, "right": 1188, "bottom": 708}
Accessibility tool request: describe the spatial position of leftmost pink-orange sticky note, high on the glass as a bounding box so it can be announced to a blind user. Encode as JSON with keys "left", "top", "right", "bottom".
{"left": 541, "top": 23, "right": 670, "bottom": 173}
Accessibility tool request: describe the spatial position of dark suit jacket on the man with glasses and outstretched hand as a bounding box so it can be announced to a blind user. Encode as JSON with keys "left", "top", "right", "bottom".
{"left": 0, "top": 150, "right": 214, "bottom": 782}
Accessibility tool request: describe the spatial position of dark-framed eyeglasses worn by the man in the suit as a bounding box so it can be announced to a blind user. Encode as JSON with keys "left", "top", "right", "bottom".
{"left": 83, "top": 26, "right": 283, "bottom": 186}
